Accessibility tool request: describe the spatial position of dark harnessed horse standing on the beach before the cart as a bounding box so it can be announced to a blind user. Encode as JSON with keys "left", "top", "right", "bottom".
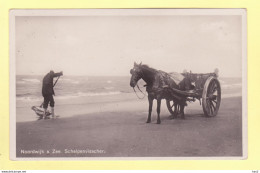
{"left": 130, "top": 63, "right": 190, "bottom": 124}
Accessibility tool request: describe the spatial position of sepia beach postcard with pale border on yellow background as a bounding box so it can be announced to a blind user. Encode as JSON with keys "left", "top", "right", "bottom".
{"left": 10, "top": 9, "right": 247, "bottom": 160}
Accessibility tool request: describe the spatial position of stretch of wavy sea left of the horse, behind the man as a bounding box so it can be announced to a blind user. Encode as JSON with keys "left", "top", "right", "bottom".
{"left": 16, "top": 75, "right": 133, "bottom": 102}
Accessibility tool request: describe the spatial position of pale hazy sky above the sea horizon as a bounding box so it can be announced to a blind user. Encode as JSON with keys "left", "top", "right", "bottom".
{"left": 15, "top": 11, "right": 242, "bottom": 77}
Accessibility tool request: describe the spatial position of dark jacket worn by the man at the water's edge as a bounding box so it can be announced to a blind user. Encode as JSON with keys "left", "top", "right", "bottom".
{"left": 42, "top": 71, "right": 62, "bottom": 97}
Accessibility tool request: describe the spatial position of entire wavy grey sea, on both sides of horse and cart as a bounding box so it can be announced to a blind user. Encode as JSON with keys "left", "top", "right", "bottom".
{"left": 16, "top": 75, "right": 242, "bottom": 106}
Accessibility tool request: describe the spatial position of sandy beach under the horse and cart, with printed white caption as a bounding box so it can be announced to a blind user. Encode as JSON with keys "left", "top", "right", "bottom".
{"left": 16, "top": 93, "right": 242, "bottom": 158}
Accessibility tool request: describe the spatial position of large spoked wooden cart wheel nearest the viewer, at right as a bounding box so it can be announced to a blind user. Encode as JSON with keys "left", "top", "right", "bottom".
{"left": 202, "top": 76, "right": 221, "bottom": 117}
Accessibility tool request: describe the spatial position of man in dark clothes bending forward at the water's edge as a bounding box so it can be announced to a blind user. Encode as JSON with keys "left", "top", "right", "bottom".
{"left": 42, "top": 70, "right": 63, "bottom": 119}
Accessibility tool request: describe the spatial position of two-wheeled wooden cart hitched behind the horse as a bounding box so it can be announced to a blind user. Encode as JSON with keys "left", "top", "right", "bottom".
{"left": 166, "top": 69, "right": 221, "bottom": 117}
